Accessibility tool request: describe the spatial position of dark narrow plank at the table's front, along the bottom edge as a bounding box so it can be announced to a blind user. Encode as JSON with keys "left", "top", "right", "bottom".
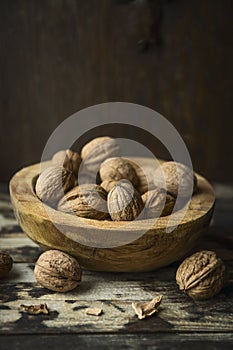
{"left": 0, "top": 333, "right": 233, "bottom": 350}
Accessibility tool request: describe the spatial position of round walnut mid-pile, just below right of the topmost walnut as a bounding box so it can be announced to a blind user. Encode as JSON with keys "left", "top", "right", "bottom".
{"left": 100, "top": 157, "right": 138, "bottom": 186}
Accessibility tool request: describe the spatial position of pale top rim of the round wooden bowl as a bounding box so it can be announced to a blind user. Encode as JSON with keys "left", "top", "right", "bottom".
{"left": 9, "top": 157, "right": 215, "bottom": 232}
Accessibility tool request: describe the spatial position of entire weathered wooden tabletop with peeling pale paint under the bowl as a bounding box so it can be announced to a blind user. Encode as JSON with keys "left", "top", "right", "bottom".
{"left": 0, "top": 184, "right": 233, "bottom": 350}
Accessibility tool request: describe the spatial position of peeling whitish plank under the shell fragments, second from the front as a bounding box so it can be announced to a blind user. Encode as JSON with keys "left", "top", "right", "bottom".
{"left": 0, "top": 296, "right": 233, "bottom": 334}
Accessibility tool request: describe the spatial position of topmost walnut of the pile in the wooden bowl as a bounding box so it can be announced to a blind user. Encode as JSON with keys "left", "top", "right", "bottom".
{"left": 81, "top": 136, "right": 120, "bottom": 174}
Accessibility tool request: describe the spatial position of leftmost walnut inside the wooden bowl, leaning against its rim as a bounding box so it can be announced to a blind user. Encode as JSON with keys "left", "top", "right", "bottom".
{"left": 35, "top": 166, "right": 75, "bottom": 206}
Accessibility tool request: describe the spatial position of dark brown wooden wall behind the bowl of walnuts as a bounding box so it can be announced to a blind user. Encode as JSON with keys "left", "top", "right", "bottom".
{"left": 0, "top": 0, "right": 233, "bottom": 182}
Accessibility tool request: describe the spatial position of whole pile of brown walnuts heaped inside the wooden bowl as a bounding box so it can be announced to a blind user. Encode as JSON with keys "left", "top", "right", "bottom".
{"left": 35, "top": 136, "right": 197, "bottom": 221}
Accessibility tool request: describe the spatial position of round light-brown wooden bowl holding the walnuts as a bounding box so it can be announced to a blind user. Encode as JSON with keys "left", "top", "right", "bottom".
{"left": 10, "top": 158, "right": 215, "bottom": 272}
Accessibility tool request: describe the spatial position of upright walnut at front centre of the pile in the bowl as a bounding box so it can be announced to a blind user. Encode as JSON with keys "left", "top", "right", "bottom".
{"left": 108, "top": 180, "right": 143, "bottom": 221}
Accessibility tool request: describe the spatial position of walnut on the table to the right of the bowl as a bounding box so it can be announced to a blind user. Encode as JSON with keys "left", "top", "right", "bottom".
{"left": 176, "top": 250, "right": 225, "bottom": 300}
